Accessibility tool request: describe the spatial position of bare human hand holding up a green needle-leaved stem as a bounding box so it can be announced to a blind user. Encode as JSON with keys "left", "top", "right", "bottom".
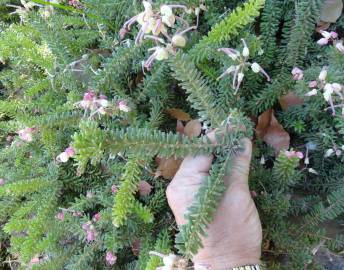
{"left": 166, "top": 132, "right": 262, "bottom": 270}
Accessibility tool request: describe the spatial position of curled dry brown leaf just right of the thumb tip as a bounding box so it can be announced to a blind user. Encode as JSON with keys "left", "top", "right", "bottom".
{"left": 256, "top": 109, "right": 290, "bottom": 154}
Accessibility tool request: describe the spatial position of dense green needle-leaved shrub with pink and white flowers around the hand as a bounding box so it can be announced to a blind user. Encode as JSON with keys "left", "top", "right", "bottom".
{"left": 0, "top": 0, "right": 344, "bottom": 270}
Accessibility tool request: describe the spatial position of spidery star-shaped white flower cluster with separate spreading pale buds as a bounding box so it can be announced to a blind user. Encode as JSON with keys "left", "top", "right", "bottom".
{"left": 218, "top": 39, "right": 270, "bottom": 93}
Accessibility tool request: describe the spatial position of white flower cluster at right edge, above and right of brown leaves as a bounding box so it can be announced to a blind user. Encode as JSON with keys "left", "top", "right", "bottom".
{"left": 305, "top": 68, "right": 344, "bottom": 115}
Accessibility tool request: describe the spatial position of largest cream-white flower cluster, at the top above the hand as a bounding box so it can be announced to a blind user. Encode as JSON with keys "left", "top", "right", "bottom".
{"left": 119, "top": 1, "right": 206, "bottom": 70}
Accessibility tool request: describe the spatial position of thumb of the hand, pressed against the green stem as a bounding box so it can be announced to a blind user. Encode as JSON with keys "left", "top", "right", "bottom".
{"left": 225, "top": 138, "right": 252, "bottom": 185}
